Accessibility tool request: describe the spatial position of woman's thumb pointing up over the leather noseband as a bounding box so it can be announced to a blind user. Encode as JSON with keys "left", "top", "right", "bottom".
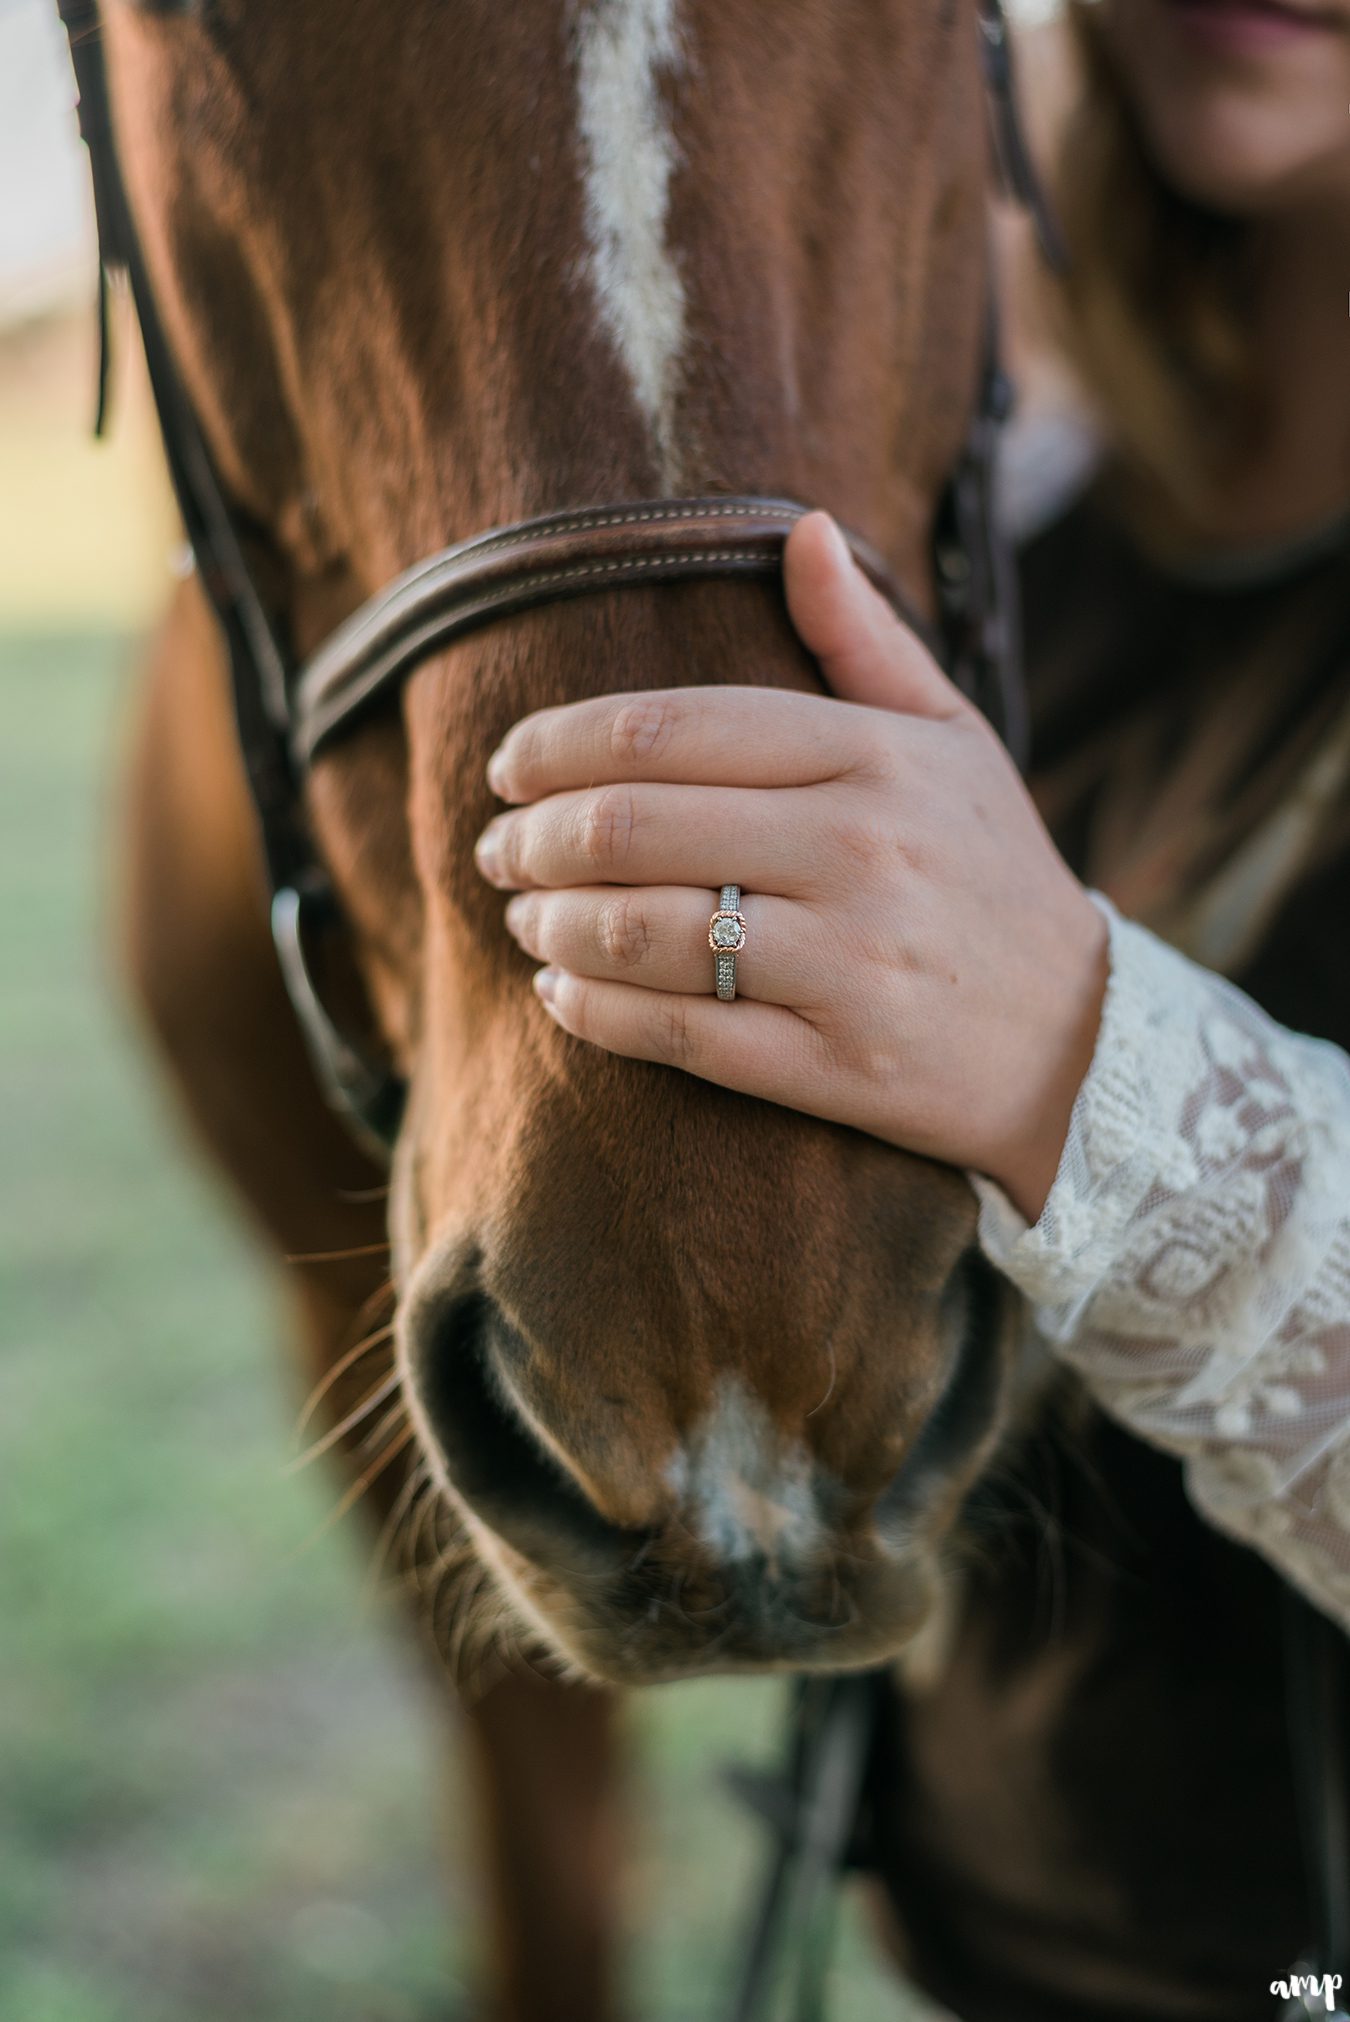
{"left": 784, "top": 512, "right": 964, "bottom": 716}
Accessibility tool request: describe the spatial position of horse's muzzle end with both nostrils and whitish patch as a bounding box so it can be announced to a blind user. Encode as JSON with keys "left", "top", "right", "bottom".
{"left": 400, "top": 1254, "right": 1002, "bottom": 1684}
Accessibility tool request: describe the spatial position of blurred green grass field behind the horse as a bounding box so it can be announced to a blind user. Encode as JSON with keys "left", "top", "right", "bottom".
{"left": 0, "top": 625, "right": 907, "bottom": 2022}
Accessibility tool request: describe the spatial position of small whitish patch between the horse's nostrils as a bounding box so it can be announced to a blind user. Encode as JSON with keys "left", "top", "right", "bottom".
{"left": 667, "top": 1377, "right": 821, "bottom": 1573}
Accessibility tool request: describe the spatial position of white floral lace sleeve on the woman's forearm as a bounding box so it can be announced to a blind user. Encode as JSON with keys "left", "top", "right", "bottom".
{"left": 970, "top": 894, "right": 1350, "bottom": 1628}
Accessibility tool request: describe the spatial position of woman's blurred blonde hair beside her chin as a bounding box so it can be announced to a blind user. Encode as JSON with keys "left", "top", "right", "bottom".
{"left": 1055, "top": 0, "right": 1257, "bottom": 530}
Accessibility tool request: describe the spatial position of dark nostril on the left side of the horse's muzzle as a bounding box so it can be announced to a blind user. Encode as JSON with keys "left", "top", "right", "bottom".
{"left": 412, "top": 1292, "right": 618, "bottom": 1559}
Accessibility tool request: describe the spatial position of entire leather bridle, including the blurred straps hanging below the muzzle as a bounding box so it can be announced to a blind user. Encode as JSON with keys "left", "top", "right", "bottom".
{"left": 57, "top": 0, "right": 1350, "bottom": 2022}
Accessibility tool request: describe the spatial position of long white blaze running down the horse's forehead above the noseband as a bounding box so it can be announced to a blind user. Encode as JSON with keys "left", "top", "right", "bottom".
{"left": 578, "top": 0, "right": 685, "bottom": 473}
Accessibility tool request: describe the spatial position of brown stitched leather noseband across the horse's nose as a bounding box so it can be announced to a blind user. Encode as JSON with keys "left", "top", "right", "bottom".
{"left": 291, "top": 495, "right": 942, "bottom": 770}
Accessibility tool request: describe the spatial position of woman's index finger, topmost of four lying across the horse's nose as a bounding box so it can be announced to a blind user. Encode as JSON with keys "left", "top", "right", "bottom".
{"left": 487, "top": 687, "right": 885, "bottom": 801}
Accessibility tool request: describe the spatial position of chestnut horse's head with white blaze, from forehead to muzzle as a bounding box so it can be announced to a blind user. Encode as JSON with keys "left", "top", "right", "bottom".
{"left": 101, "top": 0, "right": 1008, "bottom": 1682}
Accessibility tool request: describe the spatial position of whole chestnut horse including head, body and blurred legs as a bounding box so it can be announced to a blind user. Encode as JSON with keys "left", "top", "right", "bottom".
{"left": 63, "top": 0, "right": 1325, "bottom": 2022}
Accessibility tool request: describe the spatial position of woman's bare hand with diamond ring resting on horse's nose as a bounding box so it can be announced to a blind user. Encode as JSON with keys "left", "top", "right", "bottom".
{"left": 479, "top": 514, "right": 1107, "bottom": 1219}
